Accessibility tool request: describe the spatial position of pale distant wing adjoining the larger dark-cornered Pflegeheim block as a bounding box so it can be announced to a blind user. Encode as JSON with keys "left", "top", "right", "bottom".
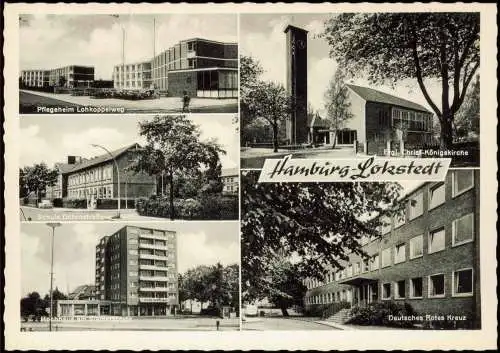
{"left": 113, "top": 61, "right": 152, "bottom": 90}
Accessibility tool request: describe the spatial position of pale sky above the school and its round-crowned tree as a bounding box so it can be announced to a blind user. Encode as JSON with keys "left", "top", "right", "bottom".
{"left": 19, "top": 114, "right": 240, "bottom": 169}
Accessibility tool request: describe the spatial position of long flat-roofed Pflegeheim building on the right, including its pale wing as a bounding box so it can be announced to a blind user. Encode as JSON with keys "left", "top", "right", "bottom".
{"left": 113, "top": 38, "right": 238, "bottom": 98}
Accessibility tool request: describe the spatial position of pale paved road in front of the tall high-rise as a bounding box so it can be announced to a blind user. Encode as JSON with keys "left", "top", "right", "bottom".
{"left": 21, "top": 318, "right": 239, "bottom": 332}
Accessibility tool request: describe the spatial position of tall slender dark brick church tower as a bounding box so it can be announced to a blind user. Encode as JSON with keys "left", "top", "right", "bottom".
{"left": 285, "top": 25, "right": 308, "bottom": 145}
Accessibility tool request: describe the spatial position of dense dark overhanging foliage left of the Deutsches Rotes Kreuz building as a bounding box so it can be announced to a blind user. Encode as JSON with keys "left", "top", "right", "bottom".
{"left": 241, "top": 171, "right": 402, "bottom": 301}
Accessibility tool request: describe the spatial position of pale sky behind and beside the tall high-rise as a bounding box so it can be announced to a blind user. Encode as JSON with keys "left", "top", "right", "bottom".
{"left": 21, "top": 222, "right": 240, "bottom": 296}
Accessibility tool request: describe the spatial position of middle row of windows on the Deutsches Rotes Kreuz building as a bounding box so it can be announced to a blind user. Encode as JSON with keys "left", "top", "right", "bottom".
{"left": 307, "top": 213, "right": 474, "bottom": 289}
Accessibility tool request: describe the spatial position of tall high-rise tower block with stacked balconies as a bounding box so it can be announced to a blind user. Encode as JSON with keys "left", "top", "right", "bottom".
{"left": 95, "top": 226, "right": 179, "bottom": 316}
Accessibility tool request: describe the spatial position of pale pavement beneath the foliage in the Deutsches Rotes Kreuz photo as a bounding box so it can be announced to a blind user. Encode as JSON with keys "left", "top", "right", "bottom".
{"left": 242, "top": 318, "right": 336, "bottom": 331}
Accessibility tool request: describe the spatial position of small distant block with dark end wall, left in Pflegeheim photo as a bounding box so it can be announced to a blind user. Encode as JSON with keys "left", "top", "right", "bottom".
{"left": 49, "top": 65, "right": 94, "bottom": 88}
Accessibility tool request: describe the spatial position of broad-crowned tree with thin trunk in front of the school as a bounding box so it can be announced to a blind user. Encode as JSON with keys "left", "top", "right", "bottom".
{"left": 130, "top": 115, "right": 226, "bottom": 219}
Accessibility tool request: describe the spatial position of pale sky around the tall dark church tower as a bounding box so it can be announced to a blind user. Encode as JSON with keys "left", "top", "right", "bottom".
{"left": 240, "top": 14, "right": 441, "bottom": 113}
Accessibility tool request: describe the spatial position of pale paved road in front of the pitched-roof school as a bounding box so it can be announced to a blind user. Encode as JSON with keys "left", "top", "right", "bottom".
{"left": 19, "top": 206, "right": 170, "bottom": 222}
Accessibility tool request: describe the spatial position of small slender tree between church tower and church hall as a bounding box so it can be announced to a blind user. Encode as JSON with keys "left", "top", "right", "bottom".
{"left": 325, "top": 68, "right": 353, "bottom": 148}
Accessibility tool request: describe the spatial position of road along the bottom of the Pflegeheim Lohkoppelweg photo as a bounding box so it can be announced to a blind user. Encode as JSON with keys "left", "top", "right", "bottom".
{"left": 19, "top": 90, "right": 238, "bottom": 114}
